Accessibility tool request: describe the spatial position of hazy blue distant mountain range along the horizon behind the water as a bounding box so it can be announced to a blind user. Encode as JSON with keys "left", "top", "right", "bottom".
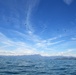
{"left": 0, "top": 54, "right": 76, "bottom": 60}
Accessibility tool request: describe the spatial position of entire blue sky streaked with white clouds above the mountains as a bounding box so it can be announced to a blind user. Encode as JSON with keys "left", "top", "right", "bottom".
{"left": 0, "top": 0, "right": 76, "bottom": 56}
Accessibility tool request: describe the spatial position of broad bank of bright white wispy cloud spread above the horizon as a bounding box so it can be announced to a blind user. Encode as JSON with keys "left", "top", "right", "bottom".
{"left": 0, "top": 32, "right": 75, "bottom": 56}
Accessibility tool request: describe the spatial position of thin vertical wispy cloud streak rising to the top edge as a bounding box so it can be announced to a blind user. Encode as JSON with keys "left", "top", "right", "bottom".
{"left": 25, "top": 0, "right": 39, "bottom": 32}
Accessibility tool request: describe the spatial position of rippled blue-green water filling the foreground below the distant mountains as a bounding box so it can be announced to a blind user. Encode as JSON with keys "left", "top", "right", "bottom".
{"left": 0, "top": 57, "right": 76, "bottom": 75}
